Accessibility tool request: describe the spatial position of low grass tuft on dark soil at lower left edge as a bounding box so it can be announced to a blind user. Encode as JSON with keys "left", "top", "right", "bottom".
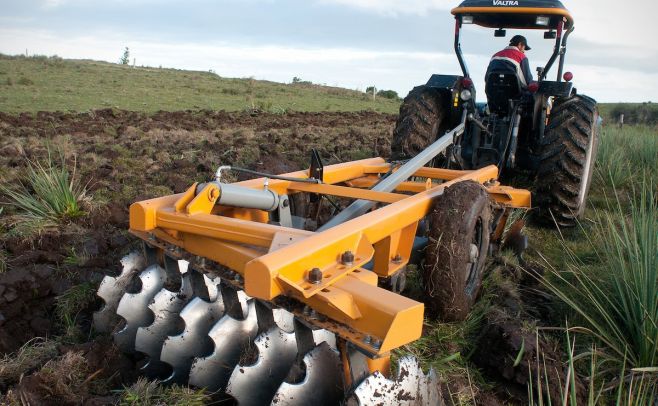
{"left": 0, "top": 338, "right": 57, "bottom": 388}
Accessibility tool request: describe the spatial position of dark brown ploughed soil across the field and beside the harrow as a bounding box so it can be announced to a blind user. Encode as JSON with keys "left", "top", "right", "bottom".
{"left": 0, "top": 110, "right": 576, "bottom": 404}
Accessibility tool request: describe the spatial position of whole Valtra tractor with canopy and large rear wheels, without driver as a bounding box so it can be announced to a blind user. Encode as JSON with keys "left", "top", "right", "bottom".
{"left": 391, "top": 0, "right": 599, "bottom": 227}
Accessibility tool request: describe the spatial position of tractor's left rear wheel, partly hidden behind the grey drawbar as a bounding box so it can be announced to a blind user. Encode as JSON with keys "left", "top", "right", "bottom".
{"left": 391, "top": 86, "right": 449, "bottom": 160}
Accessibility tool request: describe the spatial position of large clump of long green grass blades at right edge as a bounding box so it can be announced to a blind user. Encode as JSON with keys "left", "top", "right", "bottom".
{"left": 544, "top": 177, "right": 658, "bottom": 404}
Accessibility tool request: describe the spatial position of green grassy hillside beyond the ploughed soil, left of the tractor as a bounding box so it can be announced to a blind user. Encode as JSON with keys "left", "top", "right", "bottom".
{"left": 0, "top": 55, "right": 399, "bottom": 113}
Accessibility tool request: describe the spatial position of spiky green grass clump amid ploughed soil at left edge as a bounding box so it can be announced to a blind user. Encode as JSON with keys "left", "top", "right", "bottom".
{"left": 0, "top": 151, "right": 87, "bottom": 230}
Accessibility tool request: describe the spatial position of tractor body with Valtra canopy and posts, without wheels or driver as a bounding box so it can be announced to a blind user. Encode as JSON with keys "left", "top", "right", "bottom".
{"left": 427, "top": 0, "right": 574, "bottom": 170}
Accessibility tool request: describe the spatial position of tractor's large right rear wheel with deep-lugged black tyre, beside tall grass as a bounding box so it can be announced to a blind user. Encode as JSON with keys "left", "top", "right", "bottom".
{"left": 534, "top": 95, "right": 599, "bottom": 227}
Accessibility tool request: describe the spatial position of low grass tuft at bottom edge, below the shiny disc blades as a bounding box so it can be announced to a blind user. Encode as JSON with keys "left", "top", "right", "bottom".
{"left": 119, "top": 378, "right": 210, "bottom": 406}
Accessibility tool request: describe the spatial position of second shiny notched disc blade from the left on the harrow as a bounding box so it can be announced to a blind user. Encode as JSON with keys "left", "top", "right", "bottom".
{"left": 114, "top": 265, "right": 167, "bottom": 352}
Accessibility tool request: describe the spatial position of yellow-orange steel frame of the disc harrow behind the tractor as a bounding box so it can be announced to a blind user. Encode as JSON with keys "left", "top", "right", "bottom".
{"left": 130, "top": 158, "right": 530, "bottom": 356}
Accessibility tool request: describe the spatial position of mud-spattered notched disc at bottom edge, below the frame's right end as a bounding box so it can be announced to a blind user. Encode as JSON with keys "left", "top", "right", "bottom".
{"left": 353, "top": 357, "right": 441, "bottom": 406}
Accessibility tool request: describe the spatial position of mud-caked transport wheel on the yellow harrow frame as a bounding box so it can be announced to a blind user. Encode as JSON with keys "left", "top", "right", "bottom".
{"left": 423, "top": 181, "right": 492, "bottom": 321}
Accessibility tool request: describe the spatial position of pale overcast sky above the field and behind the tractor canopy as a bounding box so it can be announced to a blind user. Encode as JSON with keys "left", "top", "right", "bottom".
{"left": 0, "top": 0, "right": 658, "bottom": 102}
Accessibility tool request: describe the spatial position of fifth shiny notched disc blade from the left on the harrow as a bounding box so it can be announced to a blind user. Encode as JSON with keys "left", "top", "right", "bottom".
{"left": 189, "top": 300, "right": 258, "bottom": 392}
